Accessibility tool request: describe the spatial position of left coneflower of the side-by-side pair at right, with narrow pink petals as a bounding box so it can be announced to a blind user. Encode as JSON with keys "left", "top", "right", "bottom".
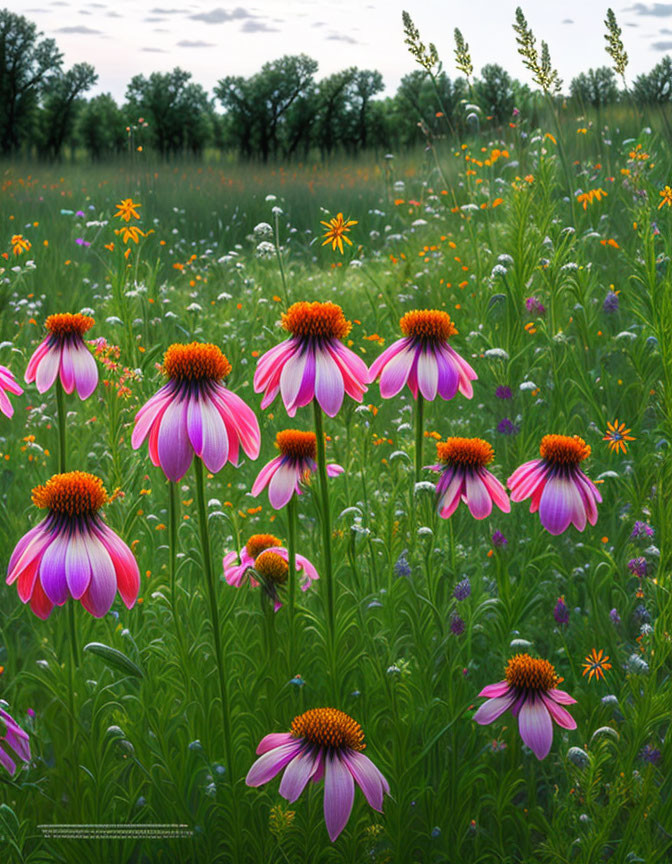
{"left": 430, "top": 438, "right": 511, "bottom": 519}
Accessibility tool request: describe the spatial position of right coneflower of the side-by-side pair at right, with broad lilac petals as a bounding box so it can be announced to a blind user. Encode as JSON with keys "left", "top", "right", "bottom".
{"left": 506, "top": 435, "right": 602, "bottom": 534}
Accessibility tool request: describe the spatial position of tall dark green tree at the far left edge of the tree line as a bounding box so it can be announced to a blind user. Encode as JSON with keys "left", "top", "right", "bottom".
{"left": 0, "top": 9, "right": 63, "bottom": 155}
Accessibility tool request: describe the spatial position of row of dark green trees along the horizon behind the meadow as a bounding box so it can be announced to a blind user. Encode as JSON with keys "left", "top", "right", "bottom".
{"left": 0, "top": 9, "right": 672, "bottom": 161}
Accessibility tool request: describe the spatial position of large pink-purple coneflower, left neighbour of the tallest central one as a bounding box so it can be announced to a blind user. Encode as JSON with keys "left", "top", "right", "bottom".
{"left": 131, "top": 342, "right": 261, "bottom": 481}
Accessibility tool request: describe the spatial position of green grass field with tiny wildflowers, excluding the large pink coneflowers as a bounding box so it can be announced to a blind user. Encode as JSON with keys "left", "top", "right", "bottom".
{"left": 0, "top": 108, "right": 672, "bottom": 864}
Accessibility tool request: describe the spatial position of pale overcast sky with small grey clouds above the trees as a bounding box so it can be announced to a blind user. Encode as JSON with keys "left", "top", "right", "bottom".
{"left": 9, "top": 0, "right": 672, "bottom": 99}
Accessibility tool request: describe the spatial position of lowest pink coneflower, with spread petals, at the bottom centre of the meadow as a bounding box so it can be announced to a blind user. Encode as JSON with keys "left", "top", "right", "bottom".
{"left": 245, "top": 708, "right": 390, "bottom": 842}
